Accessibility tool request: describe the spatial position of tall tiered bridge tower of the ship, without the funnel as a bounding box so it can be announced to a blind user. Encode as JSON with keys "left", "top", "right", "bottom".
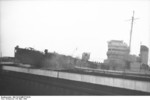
{"left": 104, "top": 40, "right": 129, "bottom": 69}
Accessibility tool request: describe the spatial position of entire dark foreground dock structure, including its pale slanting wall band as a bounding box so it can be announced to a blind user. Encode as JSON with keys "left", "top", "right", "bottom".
{"left": 0, "top": 64, "right": 150, "bottom": 95}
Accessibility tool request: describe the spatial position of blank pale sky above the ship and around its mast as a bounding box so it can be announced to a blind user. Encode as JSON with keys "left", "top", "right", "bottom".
{"left": 0, "top": 0, "right": 150, "bottom": 63}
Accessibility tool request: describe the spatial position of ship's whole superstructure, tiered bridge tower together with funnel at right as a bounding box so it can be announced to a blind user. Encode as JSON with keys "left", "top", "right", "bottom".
{"left": 104, "top": 40, "right": 149, "bottom": 71}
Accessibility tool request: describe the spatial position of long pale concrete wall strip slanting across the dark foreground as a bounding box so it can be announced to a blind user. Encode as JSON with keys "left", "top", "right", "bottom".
{"left": 2, "top": 66, "right": 150, "bottom": 93}
